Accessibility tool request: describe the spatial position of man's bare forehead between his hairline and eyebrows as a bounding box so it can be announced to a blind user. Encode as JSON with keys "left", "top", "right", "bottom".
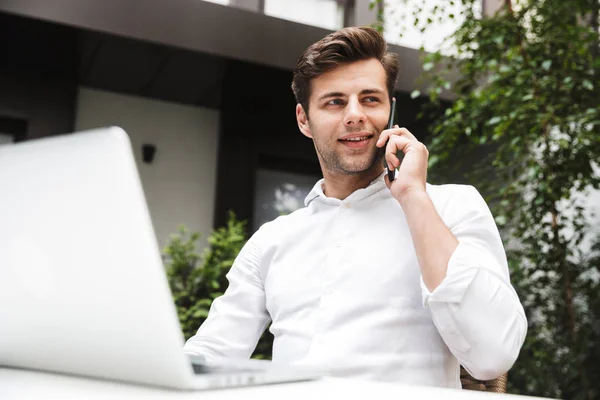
{"left": 311, "top": 58, "right": 387, "bottom": 98}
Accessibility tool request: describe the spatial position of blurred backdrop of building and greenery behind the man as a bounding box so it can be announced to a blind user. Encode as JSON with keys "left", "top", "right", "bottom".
{"left": 0, "top": 0, "right": 600, "bottom": 399}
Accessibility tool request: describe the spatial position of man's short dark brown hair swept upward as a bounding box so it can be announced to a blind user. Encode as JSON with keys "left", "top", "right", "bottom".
{"left": 292, "top": 26, "right": 398, "bottom": 114}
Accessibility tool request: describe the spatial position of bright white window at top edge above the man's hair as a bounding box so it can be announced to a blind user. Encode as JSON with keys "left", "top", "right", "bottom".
{"left": 265, "top": 0, "right": 344, "bottom": 31}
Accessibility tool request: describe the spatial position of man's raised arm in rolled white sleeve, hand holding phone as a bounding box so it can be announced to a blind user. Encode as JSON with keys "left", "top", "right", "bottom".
{"left": 377, "top": 127, "right": 527, "bottom": 380}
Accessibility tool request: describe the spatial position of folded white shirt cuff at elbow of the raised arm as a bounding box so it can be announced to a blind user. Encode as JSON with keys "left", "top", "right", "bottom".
{"left": 421, "top": 242, "right": 479, "bottom": 308}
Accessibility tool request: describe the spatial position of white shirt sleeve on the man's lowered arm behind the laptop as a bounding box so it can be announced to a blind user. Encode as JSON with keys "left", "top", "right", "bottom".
{"left": 184, "top": 230, "right": 270, "bottom": 361}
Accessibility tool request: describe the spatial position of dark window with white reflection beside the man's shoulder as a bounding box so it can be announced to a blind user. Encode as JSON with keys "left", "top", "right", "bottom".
{"left": 253, "top": 168, "right": 321, "bottom": 231}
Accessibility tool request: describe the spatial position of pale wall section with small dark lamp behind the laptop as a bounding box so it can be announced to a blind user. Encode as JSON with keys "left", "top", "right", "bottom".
{"left": 75, "top": 87, "right": 219, "bottom": 247}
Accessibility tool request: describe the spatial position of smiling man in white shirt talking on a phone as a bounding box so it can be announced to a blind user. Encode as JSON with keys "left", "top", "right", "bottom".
{"left": 185, "top": 28, "right": 527, "bottom": 387}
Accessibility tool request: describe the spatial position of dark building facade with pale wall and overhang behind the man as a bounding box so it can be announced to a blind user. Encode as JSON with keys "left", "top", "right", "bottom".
{"left": 0, "top": 0, "right": 474, "bottom": 245}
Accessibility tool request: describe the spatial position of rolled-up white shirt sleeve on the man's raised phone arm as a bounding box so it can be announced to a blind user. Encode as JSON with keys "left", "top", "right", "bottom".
{"left": 421, "top": 186, "right": 527, "bottom": 380}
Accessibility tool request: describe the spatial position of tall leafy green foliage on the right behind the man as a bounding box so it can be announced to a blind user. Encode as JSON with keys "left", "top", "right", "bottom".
{"left": 376, "top": 0, "right": 600, "bottom": 399}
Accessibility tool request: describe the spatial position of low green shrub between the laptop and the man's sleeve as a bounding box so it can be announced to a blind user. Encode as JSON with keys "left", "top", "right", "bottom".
{"left": 163, "top": 213, "right": 272, "bottom": 358}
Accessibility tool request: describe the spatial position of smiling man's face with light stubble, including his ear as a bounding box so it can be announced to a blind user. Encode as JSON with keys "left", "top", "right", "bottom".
{"left": 296, "top": 59, "right": 390, "bottom": 175}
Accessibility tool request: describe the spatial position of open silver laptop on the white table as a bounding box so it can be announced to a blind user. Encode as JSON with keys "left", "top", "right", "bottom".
{"left": 0, "top": 127, "right": 318, "bottom": 389}
